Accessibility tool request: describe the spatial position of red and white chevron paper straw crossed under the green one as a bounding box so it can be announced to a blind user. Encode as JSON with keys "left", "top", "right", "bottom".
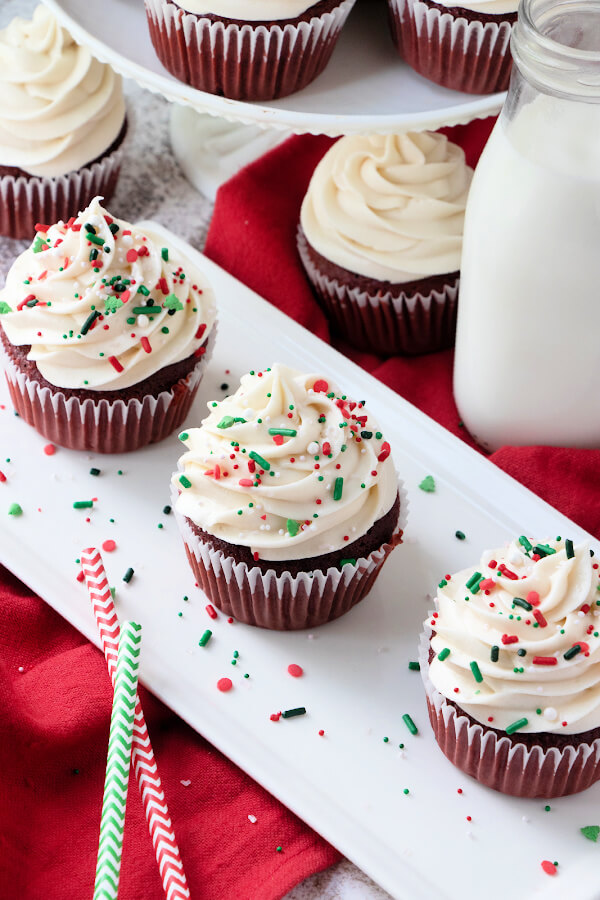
{"left": 81, "top": 547, "right": 190, "bottom": 900}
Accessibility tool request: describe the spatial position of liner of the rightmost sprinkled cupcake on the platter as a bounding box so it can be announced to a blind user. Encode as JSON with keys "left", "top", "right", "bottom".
{"left": 419, "top": 628, "right": 600, "bottom": 800}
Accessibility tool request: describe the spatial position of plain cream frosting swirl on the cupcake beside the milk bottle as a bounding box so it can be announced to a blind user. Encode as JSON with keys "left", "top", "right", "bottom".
{"left": 301, "top": 131, "right": 473, "bottom": 283}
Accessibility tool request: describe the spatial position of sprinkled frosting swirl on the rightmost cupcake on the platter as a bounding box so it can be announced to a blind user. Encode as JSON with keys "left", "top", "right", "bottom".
{"left": 426, "top": 537, "right": 600, "bottom": 734}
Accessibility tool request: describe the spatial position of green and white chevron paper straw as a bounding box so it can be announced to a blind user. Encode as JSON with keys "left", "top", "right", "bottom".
{"left": 94, "top": 622, "right": 142, "bottom": 900}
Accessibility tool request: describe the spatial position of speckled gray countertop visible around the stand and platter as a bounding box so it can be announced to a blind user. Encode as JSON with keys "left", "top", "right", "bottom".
{"left": 0, "top": 0, "right": 390, "bottom": 900}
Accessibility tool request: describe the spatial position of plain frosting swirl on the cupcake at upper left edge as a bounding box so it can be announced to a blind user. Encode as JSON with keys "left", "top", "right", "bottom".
{"left": 0, "top": 6, "right": 125, "bottom": 177}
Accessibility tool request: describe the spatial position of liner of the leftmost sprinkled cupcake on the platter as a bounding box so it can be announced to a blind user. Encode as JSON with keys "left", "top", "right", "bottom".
{"left": 2, "top": 343, "right": 211, "bottom": 453}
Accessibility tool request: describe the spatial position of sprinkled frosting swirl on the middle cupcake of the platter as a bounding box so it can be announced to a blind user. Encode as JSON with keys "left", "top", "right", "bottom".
{"left": 173, "top": 364, "right": 398, "bottom": 560}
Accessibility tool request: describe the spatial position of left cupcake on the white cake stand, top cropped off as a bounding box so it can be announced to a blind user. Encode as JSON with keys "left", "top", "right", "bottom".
{"left": 145, "top": 0, "right": 355, "bottom": 100}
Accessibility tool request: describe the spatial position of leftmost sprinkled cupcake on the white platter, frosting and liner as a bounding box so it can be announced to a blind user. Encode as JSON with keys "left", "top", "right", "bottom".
{"left": 0, "top": 197, "right": 215, "bottom": 453}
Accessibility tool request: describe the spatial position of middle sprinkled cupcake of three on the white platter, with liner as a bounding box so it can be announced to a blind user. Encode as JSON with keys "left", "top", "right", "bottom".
{"left": 173, "top": 365, "right": 407, "bottom": 630}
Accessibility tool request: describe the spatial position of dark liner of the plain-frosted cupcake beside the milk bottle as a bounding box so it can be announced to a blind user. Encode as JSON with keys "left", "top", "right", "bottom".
{"left": 297, "top": 227, "right": 459, "bottom": 356}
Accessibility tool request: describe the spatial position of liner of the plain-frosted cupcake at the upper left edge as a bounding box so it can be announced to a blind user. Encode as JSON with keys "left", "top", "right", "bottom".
{"left": 0, "top": 144, "right": 123, "bottom": 239}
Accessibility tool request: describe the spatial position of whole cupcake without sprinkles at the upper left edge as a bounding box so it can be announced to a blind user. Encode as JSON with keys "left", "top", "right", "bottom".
{"left": 0, "top": 6, "right": 126, "bottom": 238}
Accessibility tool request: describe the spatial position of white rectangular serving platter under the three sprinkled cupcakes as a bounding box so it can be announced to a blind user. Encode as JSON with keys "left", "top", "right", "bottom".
{"left": 0, "top": 223, "right": 600, "bottom": 900}
